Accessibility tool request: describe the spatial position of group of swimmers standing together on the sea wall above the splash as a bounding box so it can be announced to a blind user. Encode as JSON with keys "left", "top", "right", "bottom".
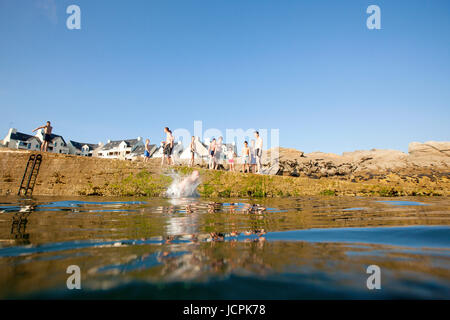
{"left": 148, "top": 127, "right": 263, "bottom": 173}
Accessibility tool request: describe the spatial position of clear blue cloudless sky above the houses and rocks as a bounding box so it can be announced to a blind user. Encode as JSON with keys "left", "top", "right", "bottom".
{"left": 0, "top": 0, "right": 450, "bottom": 153}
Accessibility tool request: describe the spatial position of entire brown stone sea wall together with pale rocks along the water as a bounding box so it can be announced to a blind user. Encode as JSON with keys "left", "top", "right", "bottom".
{"left": 0, "top": 142, "right": 450, "bottom": 197}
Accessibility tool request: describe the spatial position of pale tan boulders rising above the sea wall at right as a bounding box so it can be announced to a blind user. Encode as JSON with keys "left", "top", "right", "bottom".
{"left": 265, "top": 141, "right": 450, "bottom": 178}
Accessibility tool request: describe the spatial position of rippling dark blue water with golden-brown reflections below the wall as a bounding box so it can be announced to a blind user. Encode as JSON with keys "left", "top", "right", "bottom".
{"left": 0, "top": 197, "right": 450, "bottom": 299}
